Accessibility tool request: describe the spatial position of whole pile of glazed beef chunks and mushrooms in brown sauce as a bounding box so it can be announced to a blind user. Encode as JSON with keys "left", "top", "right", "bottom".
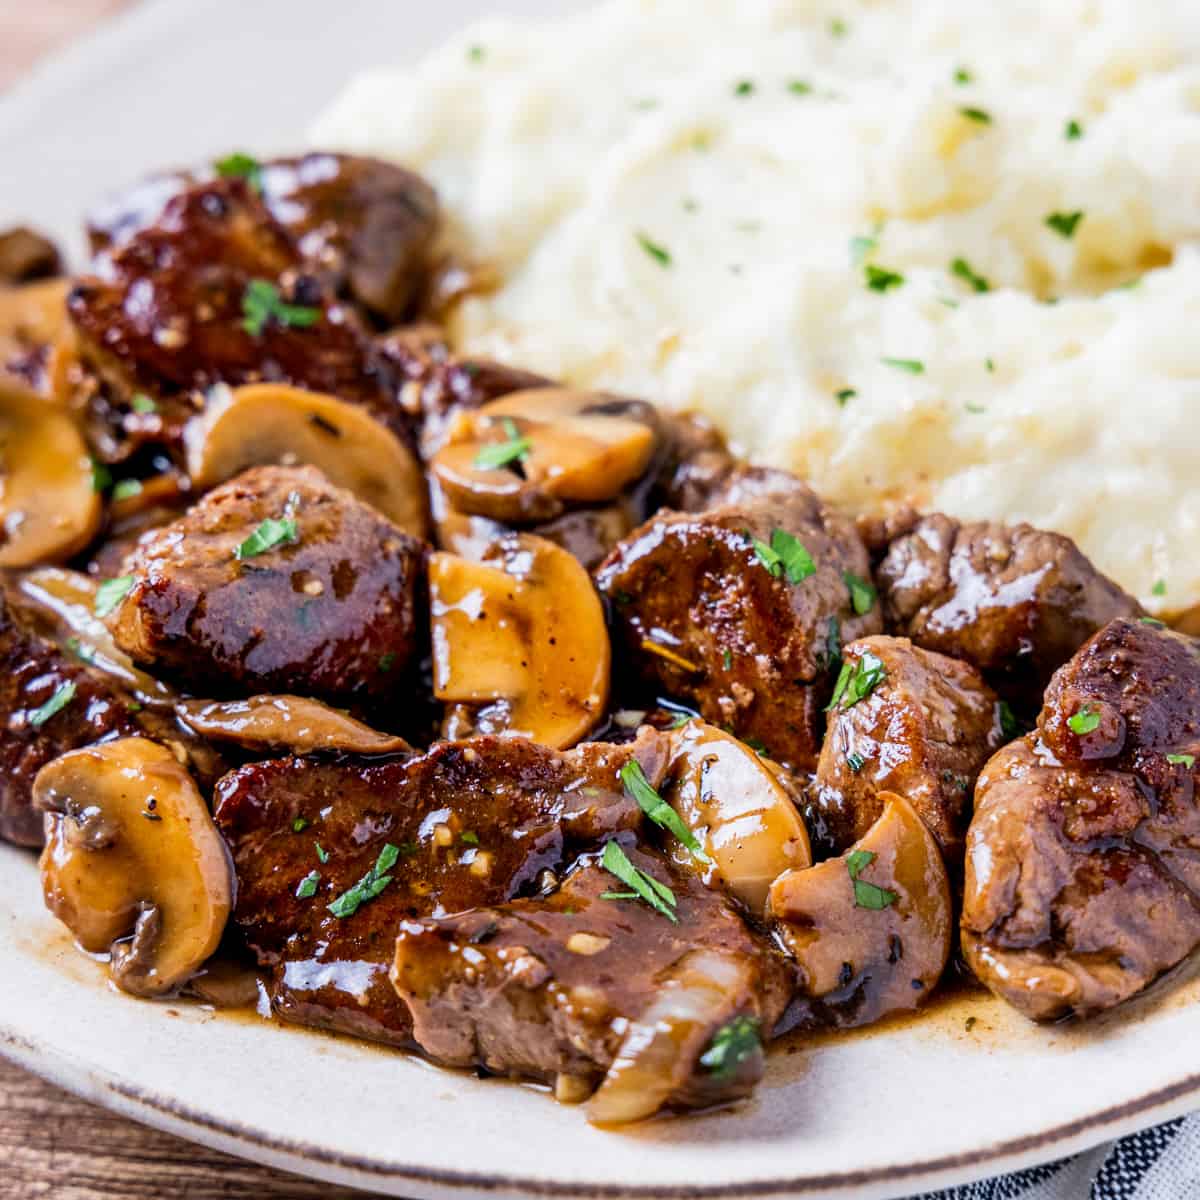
{"left": 0, "top": 154, "right": 1200, "bottom": 1124}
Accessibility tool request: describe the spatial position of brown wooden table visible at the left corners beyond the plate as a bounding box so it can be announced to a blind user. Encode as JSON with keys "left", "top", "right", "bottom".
{"left": 0, "top": 0, "right": 388, "bottom": 1200}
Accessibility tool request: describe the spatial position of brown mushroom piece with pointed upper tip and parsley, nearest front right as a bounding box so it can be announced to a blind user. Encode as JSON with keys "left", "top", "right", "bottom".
{"left": 767, "top": 792, "right": 952, "bottom": 1025}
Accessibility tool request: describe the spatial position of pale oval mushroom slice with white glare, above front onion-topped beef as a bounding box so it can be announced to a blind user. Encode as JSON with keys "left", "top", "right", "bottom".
{"left": 661, "top": 721, "right": 812, "bottom": 916}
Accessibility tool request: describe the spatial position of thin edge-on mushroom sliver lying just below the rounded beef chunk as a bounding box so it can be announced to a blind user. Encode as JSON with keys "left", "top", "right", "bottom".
{"left": 175, "top": 696, "right": 412, "bottom": 754}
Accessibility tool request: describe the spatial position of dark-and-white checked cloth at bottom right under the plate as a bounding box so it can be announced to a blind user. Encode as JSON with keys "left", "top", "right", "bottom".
{"left": 913, "top": 1115, "right": 1200, "bottom": 1200}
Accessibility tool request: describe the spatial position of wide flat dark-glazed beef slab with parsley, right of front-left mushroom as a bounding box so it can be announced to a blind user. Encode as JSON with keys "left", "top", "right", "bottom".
{"left": 216, "top": 733, "right": 665, "bottom": 1045}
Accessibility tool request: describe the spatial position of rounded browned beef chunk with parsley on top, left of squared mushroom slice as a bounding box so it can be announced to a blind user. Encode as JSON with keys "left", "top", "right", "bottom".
{"left": 109, "top": 467, "right": 424, "bottom": 703}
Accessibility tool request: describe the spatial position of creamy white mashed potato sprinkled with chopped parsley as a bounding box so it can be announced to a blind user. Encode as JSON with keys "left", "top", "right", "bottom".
{"left": 316, "top": 0, "right": 1200, "bottom": 611}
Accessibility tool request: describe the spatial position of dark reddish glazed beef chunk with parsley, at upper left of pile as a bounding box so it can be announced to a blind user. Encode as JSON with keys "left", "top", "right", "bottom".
{"left": 68, "top": 179, "right": 398, "bottom": 460}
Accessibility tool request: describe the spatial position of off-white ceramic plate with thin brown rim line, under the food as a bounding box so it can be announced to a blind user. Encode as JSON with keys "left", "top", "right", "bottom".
{"left": 0, "top": 0, "right": 1200, "bottom": 1198}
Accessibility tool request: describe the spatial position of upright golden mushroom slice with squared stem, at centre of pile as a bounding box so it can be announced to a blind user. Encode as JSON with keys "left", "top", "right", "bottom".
{"left": 430, "top": 534, "right": 611, "bottom": 749}
